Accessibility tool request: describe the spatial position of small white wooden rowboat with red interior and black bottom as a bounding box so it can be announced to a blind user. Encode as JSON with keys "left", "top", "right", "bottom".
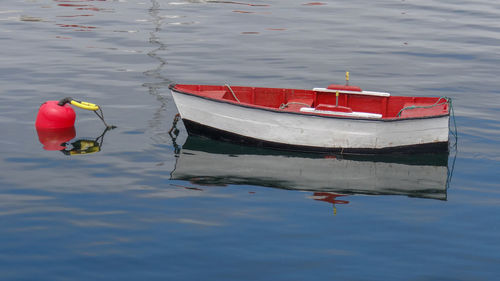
{"left": 169, "top": 80, "right": 451, "bottom": 154}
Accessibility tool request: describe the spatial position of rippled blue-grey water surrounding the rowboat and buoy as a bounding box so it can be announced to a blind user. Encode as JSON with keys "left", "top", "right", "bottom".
{"left": 0, "top": 0, "right": 500, "bottom": 280}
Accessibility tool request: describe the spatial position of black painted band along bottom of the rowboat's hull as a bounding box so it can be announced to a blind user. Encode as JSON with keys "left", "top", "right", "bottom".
{"left": 182, "top": 119, "right": 448, "bottom": 154}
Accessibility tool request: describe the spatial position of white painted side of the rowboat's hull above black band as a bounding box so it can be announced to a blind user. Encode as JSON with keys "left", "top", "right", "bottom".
{"left": 172, "top": 91, "right": 449, "bottom": 149}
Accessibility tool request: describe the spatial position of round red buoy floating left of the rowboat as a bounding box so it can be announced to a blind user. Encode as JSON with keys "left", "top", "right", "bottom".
{"left": 35, "top": 101, "right": 76, "bottom": 129}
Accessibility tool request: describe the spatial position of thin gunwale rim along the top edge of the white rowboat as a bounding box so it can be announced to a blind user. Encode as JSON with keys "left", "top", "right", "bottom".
{"left": 168, "top": 84, "right": 450, "bottom": 122}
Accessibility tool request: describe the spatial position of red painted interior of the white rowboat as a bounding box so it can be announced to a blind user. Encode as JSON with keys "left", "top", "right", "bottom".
{"left": 175, "top": 84, "right": 449, "bottom": 119}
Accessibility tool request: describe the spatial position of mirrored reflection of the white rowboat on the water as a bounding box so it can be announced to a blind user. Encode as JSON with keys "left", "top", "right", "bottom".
{"left": 171, "top": 136, "right": 449, "bottom": 210}
